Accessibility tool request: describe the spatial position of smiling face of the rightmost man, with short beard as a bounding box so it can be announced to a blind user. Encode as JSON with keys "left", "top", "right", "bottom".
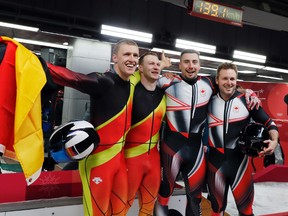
{"left": 216, "top": 68, "right": 237, "bottom": 100}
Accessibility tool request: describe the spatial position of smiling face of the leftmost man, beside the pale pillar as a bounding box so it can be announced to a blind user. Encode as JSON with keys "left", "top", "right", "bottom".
{"left": 112, "top": 43, "right": 139, "bottom": 80}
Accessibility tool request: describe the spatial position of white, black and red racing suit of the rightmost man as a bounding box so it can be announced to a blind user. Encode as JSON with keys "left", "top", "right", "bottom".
{"left": 207, "top": 91, "right": 277, "bottom": 216}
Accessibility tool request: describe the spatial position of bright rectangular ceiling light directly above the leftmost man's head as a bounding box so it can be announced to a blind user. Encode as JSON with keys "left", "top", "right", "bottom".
{"left": 101, "top": 25, "right": 153, "bottom": 43}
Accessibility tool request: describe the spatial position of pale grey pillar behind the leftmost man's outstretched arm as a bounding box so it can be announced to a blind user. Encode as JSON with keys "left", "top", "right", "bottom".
{"left": 62, "top": 39, "right": 111, "bottom": 123}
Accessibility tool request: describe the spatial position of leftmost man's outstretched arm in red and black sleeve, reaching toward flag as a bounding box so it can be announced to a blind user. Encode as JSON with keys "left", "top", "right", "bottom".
{"left": 47, "top": 63, "right": 114, "bottom": 94}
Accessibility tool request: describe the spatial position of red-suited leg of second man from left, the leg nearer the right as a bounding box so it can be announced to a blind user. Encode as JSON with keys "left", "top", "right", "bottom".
{"left": 138, "top": 148, "right": 161, "bottom": 216}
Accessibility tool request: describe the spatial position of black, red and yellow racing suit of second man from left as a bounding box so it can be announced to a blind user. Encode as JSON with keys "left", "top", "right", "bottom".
{"left": 124, "top": 82, "right": 166, "bottom": 216}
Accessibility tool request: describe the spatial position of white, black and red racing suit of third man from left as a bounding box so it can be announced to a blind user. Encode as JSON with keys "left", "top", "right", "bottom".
{"left": 155, "top": 76, "right": 215, "bottom": 216}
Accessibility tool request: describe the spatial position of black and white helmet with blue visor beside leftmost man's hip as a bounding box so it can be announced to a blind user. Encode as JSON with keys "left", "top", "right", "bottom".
{"left": 49, "top": 120, "right": 100, "bottom": 163}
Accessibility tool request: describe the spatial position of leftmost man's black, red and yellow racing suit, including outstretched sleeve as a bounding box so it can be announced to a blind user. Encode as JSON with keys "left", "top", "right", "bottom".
{"left": 48, "top": 64, "right": 134, "bottom": 216}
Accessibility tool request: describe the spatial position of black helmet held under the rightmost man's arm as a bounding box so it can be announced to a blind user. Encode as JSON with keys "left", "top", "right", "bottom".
{"left": 238, "top": 123, "right": 270, "bottom": 157}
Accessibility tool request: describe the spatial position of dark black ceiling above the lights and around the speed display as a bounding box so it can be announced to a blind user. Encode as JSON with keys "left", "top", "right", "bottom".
{"left": 0, "top": 0, "right": 288, "bottom": 82}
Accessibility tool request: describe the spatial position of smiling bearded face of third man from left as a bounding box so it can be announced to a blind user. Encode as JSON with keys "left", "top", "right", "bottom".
{"left": 179, "top": 53, "right": 200, "bottom": 80}
